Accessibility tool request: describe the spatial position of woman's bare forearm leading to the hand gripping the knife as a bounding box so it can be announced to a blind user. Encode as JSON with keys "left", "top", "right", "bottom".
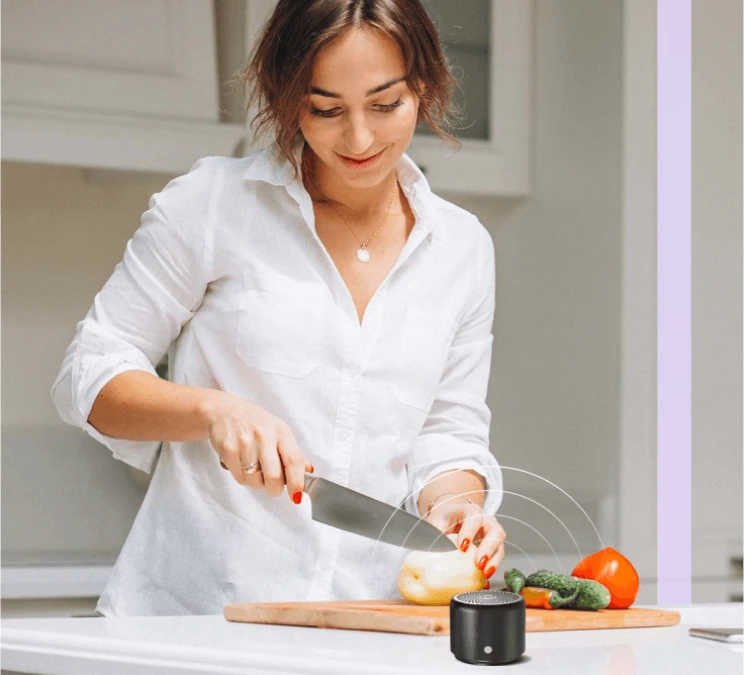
{"left": 88, "top": 370, "right": 225, "bottom": 441}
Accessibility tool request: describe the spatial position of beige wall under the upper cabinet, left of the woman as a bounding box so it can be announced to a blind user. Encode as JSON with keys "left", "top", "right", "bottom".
{"left": 2, "top": 162, "right": 166, "bottom": 564}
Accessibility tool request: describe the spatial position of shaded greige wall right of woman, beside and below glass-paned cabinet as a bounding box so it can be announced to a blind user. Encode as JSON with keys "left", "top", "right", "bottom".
{"left": 450, "top": 0, "right": 622, "bottom": 553}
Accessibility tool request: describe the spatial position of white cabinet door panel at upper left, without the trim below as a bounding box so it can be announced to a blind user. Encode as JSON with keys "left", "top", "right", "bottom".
{"left": 2, "top": 0, "right": 219, "bottom": 121}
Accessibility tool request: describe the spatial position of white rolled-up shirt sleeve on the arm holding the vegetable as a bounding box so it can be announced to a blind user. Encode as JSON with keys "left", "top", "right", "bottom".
{"left": 405, "top": 229, "right": 503, "bottom": 516}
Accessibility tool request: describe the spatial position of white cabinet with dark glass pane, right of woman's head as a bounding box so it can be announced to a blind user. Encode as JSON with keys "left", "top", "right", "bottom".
{"left": 409, "top": 0, "right": 534, "bottom": 196}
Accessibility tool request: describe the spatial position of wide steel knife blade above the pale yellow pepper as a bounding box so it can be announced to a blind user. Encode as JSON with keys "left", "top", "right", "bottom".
{"left": 304, "top": 473, "right": 457, "bottom": 552}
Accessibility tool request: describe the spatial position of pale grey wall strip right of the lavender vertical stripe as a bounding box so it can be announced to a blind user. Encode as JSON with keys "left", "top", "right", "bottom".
{"left": 692, "top": 0, "right": 743, "bottom": 602}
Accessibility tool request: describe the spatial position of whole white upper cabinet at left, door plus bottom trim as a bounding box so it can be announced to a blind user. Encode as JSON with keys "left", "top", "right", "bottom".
{"left": 2, "top": 0, "right": 243, "bottom": 173}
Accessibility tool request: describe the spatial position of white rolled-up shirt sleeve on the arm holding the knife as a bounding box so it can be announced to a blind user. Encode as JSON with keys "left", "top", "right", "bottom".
{"left": 51, "top": 158, "right": 216, "bottom": 472}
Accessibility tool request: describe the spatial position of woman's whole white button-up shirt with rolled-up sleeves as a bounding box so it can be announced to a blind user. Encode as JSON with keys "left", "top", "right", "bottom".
{"left": 52, "top": 143, "right": 502, "bottom": 616}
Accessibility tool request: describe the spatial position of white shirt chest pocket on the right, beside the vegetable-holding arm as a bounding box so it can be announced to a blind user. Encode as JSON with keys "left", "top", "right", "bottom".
{"left": 391, "top": 307, "right": 453, "bottom": 412}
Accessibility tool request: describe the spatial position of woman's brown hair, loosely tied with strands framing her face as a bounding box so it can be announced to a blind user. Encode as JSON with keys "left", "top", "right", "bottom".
{"left": 238, "top": 0, "right": 459, "bottom": 177}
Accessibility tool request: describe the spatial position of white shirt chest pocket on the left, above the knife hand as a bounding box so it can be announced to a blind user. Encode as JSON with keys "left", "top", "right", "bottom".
{"left": 237, "top": 282, "right": 326, "bottom": 378}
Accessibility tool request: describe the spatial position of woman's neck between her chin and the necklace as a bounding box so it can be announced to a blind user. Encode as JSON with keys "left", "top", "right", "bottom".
{"left": 302, "top": 145, "right": 398, "bottom": 218}
